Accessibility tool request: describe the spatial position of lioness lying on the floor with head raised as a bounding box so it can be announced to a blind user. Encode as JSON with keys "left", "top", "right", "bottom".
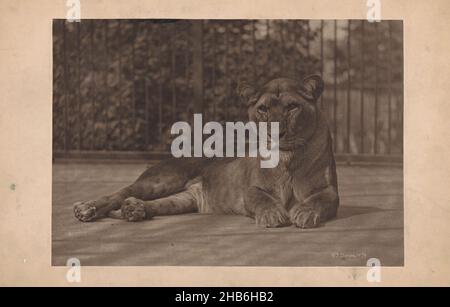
{"left": 74, "top": 75, "right": 339, "bottom": 228}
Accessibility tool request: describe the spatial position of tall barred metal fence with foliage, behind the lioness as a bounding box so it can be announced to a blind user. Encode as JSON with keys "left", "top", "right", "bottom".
{"left": 53, "top": 20, "right": 403, "bottom": 161}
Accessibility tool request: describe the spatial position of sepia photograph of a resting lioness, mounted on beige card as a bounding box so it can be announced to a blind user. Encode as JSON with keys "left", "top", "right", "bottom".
{"left": 51, "top": 19, "right": 404, "bottom": 267}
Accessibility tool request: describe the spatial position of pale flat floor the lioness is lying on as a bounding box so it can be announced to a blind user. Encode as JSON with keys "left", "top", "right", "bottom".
{"left": 52, "top": 163, "right": 403, "bottom": 266}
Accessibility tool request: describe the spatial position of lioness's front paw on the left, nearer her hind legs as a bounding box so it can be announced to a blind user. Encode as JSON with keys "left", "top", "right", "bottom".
{"left": 245, "top": 187, "right": 291, "bottom": 228}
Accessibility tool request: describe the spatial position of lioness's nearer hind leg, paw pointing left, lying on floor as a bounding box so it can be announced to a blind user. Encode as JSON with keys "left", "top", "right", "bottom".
{"left": 119, "top": 184, "right": 199, "bottom": 222}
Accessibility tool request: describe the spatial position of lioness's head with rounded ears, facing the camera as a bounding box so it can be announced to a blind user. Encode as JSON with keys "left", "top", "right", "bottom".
{"left": 239, "top": 76, "right": 323, "bottom": 151}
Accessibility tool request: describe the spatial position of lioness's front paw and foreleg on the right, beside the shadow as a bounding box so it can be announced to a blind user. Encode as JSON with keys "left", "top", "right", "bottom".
{"left": 289, "top": 186, "right": 339, "bottom": 228}
